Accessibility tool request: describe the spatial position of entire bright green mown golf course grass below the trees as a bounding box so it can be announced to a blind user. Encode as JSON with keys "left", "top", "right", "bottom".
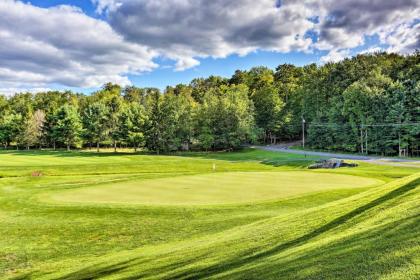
{"left": 0, "top": 149, "right": 420, "bottom": 279}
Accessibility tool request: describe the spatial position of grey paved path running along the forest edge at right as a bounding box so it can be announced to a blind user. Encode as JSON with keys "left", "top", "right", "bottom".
{"left": 255, "top": 144, "right": 420, "bottom": 168}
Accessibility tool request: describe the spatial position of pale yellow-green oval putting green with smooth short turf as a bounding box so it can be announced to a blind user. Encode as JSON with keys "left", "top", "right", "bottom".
{"left": 44, "top": 171, "right": 382, "bottom": 205}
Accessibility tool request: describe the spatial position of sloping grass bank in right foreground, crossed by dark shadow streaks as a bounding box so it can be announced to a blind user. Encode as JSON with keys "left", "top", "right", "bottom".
{"left": 39, "top": 175, "right": 420, "bottom": 279}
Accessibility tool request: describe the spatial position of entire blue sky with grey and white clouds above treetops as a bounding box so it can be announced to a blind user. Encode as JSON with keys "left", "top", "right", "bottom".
{"left": 0, "top": 0, "right": 420, "bottom": 95}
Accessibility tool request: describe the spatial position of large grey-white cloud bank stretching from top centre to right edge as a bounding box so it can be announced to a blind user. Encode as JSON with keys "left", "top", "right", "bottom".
{"left": 97, "top": 0, "right": 420, "bottom": 70}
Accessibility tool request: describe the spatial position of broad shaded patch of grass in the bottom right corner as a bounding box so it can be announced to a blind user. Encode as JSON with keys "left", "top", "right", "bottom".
{"left": 236, "top": 215, "right": 420, "bottom": 279}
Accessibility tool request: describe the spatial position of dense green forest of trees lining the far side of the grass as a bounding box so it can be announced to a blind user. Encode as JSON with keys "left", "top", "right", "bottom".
{"left": 0, "top": 51, "right": 420, "bottom": 156}
